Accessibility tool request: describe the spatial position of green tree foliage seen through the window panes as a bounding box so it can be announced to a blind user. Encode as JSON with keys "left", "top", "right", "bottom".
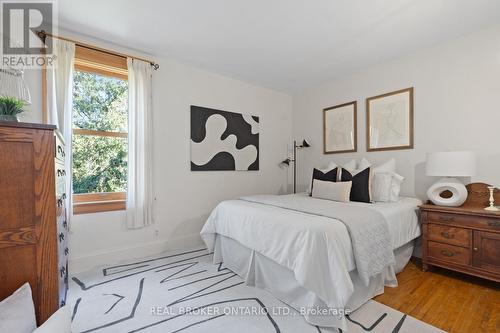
{"left": 73, "top": 71, "right": 128, "bottom": 193}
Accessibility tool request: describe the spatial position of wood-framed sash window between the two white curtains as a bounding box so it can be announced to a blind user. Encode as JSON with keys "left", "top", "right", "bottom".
{"left": 73, "top": 46, "right": 128, "bottom": 214}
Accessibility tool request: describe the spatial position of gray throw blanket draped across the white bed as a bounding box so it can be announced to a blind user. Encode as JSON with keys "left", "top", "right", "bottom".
{"left": 240, "top": 195, "right": 395, "bottom": 286}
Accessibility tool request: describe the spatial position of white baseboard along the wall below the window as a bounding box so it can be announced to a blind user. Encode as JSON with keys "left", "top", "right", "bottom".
{"left": 68, "top": 234, "right": 205, "bottom": 275}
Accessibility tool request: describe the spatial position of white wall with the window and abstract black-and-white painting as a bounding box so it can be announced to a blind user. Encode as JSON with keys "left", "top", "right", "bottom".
{"left": 27, "top": 32, "right": 292, "bottom": 273}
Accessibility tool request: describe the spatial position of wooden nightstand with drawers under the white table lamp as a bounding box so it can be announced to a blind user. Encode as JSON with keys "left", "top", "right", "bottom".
{"left": 420, "top": 183, "right": 500, "bottom": 282}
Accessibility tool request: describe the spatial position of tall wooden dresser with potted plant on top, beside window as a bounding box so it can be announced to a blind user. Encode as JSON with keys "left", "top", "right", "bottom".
{"left": 0, "top": 122, "right": 68, "bottom": 324}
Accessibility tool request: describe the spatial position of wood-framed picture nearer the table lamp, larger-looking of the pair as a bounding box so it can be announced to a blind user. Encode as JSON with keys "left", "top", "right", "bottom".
{"left": 366, "top": 87, "right": 414, "bottom": 152}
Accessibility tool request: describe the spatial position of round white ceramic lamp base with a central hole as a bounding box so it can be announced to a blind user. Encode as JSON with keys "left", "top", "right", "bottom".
{"left": 427, "top": 178, "right": 468, "bottom": 207}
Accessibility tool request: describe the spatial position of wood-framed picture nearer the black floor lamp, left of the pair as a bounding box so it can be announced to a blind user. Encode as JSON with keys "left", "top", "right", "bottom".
{"left": 323, "top": 101, "right": 358, "bottom": 154}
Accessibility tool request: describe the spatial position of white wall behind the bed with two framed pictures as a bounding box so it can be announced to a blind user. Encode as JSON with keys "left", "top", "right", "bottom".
{"left": 293, "top": 26, "right": 500, "bottom": 198}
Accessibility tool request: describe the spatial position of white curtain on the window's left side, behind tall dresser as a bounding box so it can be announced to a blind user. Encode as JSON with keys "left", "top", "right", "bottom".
{"left": 47, "top": 39, "right": 75, "bottom": 225}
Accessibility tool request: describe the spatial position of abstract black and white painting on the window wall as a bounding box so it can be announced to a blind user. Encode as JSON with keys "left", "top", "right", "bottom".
{"left": 191, "top": 105, "right": 259, "bottom": 171}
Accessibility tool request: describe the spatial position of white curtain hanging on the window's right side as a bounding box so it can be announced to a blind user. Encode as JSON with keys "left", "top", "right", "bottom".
{"left": 127, "top": 58, "right": 153, "bottom": 229}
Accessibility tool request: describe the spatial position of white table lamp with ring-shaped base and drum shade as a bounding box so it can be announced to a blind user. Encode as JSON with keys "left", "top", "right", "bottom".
{"left": 426, "top": 151, "right": 476, "bottom": 207}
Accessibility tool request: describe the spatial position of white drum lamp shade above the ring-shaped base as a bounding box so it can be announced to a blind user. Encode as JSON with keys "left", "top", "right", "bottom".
{"left": 426, "top": 151, "right": 476, "bottom": 177}
